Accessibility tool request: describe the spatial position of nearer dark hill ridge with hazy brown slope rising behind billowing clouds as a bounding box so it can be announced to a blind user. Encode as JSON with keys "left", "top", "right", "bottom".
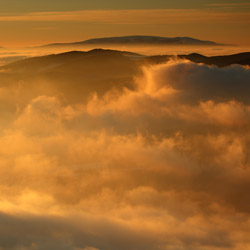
{"left": 0, "top": 49, "right": 250, "bottom": 108}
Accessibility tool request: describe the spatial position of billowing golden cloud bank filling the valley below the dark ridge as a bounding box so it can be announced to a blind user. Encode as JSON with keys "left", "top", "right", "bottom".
{"left": 0, "top": 61, "right": 250, "bottom": 250}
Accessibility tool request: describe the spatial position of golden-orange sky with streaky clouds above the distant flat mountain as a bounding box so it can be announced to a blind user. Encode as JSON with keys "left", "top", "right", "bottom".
{"left": 0, "top": 0, "right": 250, "bottom": 47}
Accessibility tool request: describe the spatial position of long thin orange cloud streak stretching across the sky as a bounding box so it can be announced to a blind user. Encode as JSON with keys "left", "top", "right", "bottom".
{"left": 0, "top": 9, "right": 250, "bottom": 24}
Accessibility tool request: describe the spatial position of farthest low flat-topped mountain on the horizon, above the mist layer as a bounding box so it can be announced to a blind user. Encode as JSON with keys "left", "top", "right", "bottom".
{"left": 42, "top": 36, "right": 222, "bottom": 48}
